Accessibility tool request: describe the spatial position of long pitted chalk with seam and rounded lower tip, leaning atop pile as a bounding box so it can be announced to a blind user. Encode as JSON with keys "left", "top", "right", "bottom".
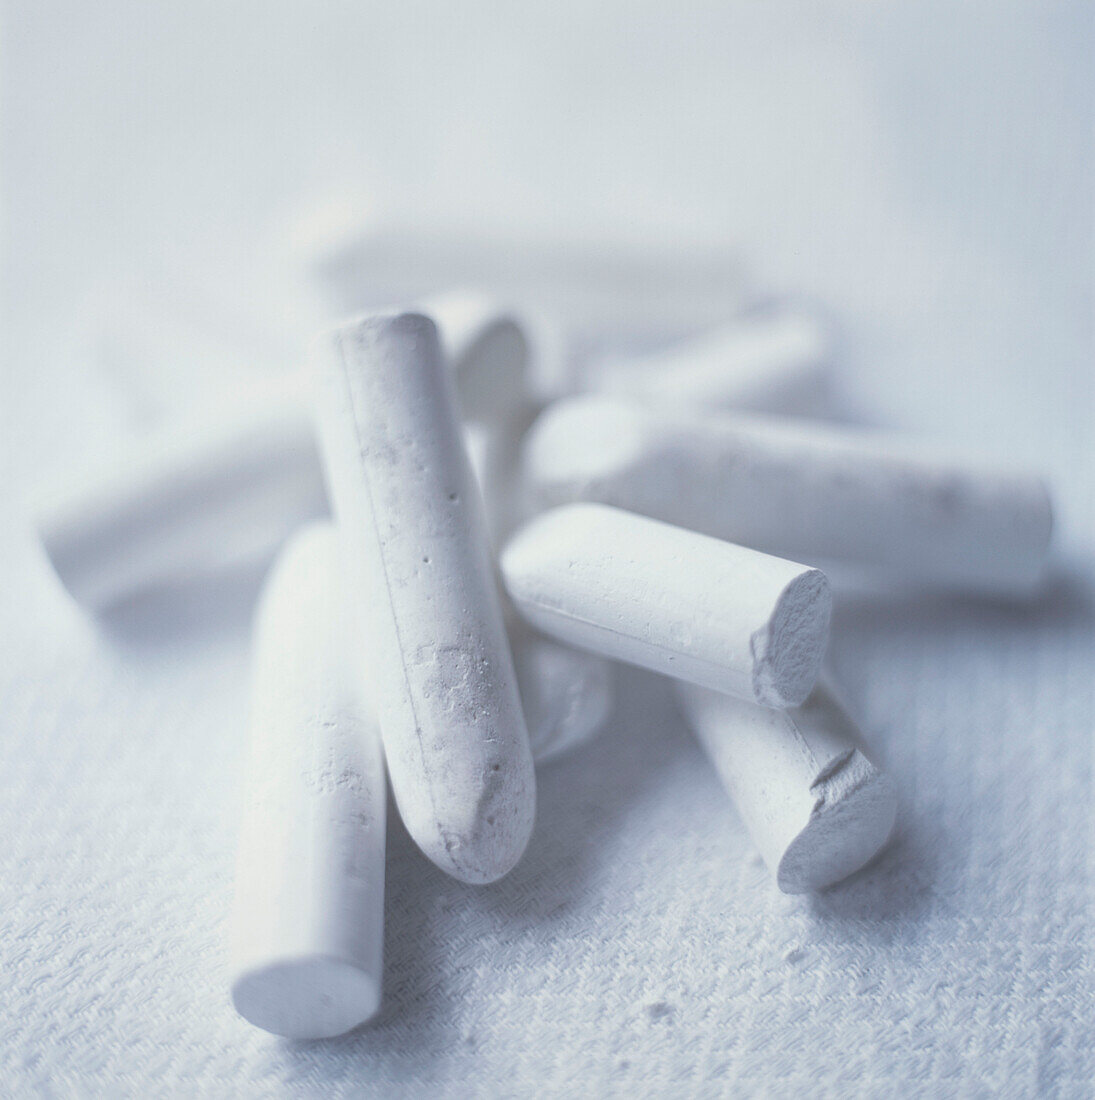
{"left": 319, "top": 314, "right": 536, "bottom": 882}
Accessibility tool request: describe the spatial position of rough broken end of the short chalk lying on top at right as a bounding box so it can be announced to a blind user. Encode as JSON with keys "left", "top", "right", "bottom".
{"left": 751, "top": 569, "right": 833, "bottom": 710}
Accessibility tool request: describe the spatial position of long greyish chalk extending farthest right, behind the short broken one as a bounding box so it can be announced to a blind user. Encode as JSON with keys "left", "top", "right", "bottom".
{"left": 525, "top": 396, "right": 1052, "bottom": 593}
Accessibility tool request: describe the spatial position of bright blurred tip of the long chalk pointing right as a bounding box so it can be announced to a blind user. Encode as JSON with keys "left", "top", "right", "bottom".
{"left": 525, "top": 394, "right": 648, "bottom": 504}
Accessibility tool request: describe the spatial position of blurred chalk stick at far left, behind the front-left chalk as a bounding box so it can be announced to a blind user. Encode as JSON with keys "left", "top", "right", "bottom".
{"left": 39, "top": 402, "right": 327, "bottom": 611}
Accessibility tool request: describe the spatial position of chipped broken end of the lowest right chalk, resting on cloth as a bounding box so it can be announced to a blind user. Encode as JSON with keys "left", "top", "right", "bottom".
{"left": 776, "top": 752, "right": 897, "bottom": 894}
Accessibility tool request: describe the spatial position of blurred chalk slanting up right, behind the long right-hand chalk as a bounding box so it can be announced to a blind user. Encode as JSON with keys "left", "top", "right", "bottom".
{"left": 584, "top": 309, "right": 833, "bottom": 416}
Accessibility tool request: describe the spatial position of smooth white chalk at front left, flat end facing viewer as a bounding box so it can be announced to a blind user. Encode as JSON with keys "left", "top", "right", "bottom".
{"left": 230, "top": 524, "right": 385, "bottom": 1038}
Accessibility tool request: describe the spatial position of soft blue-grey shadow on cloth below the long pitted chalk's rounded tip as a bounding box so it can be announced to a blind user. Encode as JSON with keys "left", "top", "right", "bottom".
{"left": 283, "top": 669, "right": 685, "bottom": 1079}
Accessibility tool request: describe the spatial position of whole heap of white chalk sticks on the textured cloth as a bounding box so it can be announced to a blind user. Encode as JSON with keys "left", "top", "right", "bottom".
{"left": 40, "top": 251, "right": 1051, "bottom": 1038}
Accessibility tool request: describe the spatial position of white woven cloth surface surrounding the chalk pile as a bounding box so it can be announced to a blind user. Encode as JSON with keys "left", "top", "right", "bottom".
{"left": 0, "top": 0, "right": 1095, "bottom": 1098}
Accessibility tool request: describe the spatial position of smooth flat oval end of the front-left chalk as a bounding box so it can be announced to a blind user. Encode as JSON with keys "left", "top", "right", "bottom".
{"left": 232, "top": 955, "right": 381, "bottom": 1040}
